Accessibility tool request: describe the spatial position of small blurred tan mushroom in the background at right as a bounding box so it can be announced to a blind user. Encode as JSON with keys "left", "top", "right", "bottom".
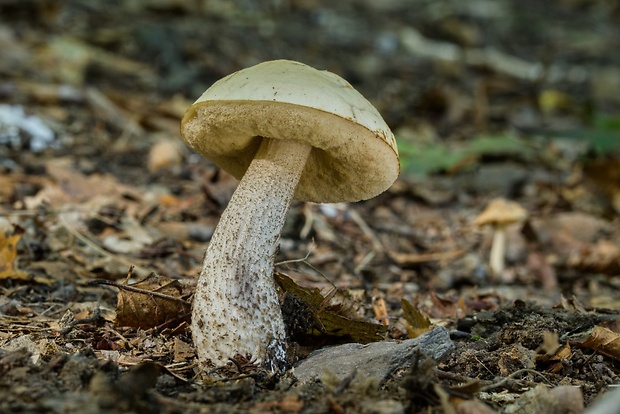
{"left": 474, "top": 198, "right": 527, "bottom": 276}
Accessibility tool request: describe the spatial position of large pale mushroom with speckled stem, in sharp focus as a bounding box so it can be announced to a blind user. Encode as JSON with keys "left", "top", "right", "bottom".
{"left": 181, "top": 60, "right": 400, "bottom": 372}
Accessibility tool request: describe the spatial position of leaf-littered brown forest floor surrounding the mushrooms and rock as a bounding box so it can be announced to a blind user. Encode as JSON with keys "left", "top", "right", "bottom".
{"left": 0, "top": 0, "right": 620, "bottom": 413}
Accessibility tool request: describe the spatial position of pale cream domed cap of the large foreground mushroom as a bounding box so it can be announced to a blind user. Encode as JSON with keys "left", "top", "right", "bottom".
{"left": 181, "top": 60, "right": 400, "bottom": 203}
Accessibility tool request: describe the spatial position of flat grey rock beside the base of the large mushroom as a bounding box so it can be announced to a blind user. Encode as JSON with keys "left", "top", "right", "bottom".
{"left": 294, "top": 327, "right": 454, "bottom": 382}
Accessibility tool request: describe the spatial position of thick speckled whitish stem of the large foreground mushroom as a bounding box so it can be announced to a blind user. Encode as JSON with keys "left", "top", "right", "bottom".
{"left": 191, "top": 138, "right": 312, "bottom": 371}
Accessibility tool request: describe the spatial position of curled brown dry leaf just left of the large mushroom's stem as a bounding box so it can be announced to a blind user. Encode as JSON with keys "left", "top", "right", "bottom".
{"left": 108, "top": 273, "right": 191, "bottom": 329}
